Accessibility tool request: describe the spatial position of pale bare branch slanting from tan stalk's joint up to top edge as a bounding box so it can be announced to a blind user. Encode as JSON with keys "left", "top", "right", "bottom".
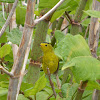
{"left": 34, "top": 0, "right": 64, "bottom": 25}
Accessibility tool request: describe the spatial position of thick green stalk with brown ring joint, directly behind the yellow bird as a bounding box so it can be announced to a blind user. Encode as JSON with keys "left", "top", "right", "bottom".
{"left": 26, "top": 20, "right": 49, "bottom": 84}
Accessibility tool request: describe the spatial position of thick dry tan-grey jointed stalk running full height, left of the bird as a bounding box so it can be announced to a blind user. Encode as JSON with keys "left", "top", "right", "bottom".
{"left": 7, "top": 0, "right": 35, "bottom": 100}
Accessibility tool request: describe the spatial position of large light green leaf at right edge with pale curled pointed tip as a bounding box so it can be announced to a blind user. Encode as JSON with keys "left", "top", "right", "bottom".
{"left": 62, "top": 56, "right": 100, "bottom": 82}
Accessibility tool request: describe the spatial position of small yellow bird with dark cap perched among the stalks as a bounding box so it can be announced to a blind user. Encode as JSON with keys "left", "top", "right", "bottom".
{"left": 40, "top": 42, "right": 59, "bottom": 74}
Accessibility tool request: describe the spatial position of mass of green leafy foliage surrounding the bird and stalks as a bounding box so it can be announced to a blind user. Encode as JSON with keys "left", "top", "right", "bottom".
{"left": 0, "top": 0, "right": 100, "bottom": 100}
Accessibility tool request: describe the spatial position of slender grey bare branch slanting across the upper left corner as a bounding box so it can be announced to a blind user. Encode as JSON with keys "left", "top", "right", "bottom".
{"left": 0, "top": 0, "right": 19, "bottom": 37}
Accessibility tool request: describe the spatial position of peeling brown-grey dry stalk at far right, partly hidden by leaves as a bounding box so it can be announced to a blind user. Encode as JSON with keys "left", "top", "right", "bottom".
{"left": 89, "top": 0, "right": 100, "bottom": 100}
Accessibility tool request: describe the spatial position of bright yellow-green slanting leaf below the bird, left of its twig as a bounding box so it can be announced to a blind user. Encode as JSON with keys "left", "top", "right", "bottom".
{"left": 25, "top": 75, "right": 47, "bottom": 96}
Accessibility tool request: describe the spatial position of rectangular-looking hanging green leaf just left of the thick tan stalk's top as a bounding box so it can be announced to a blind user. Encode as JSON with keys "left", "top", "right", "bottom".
{"left": 16, "top": 4, "right": 26, "bottom": 26}
